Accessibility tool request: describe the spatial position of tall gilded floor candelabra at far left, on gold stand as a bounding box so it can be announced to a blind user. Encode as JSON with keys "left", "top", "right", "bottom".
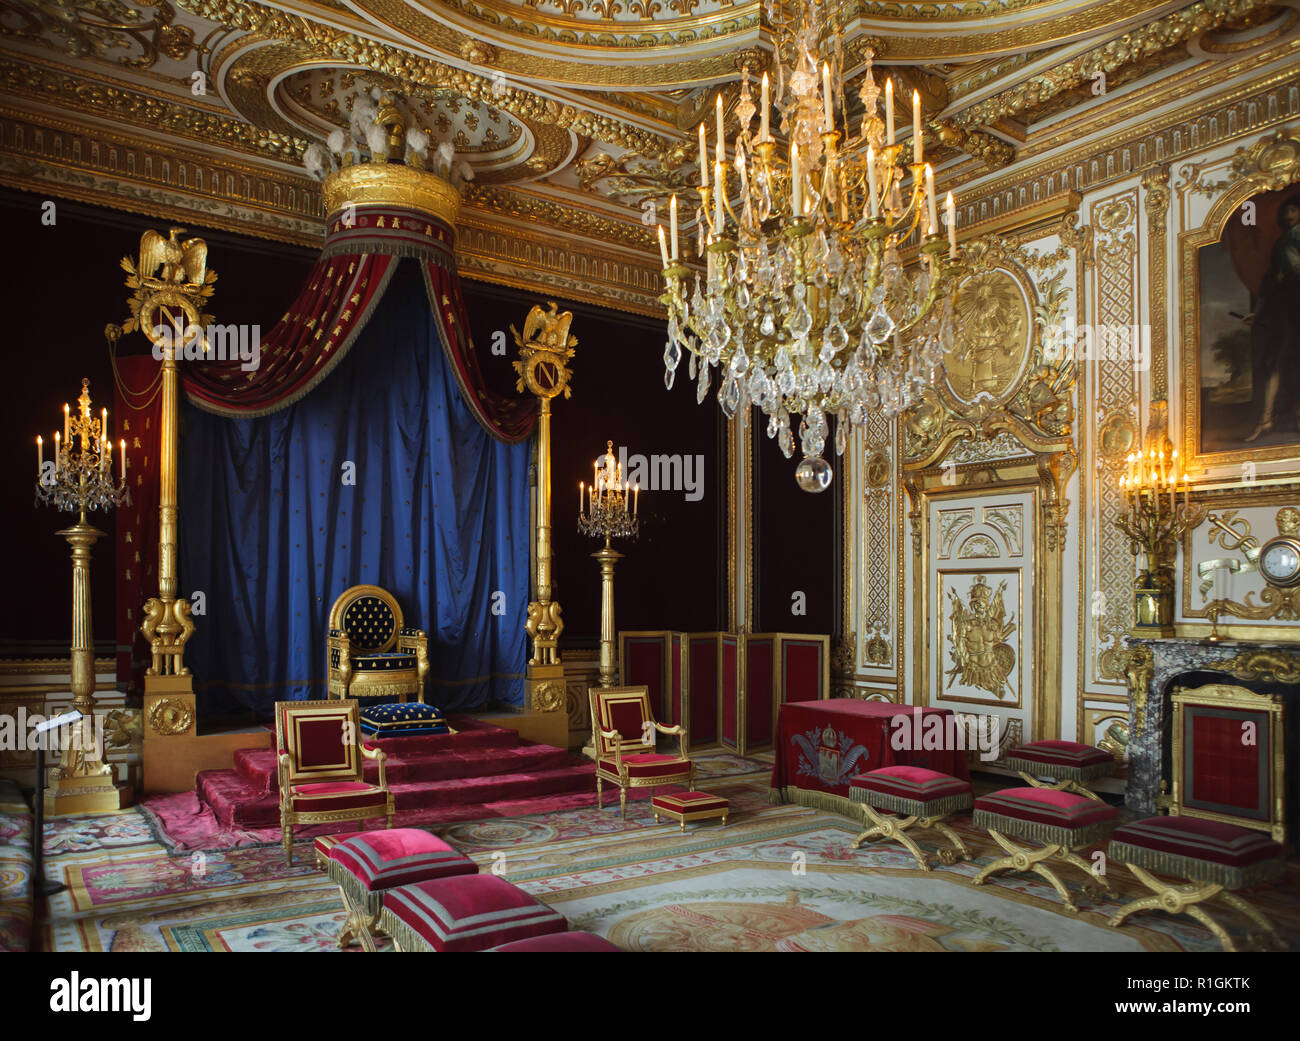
{"left": 36, "top": 379, "right": 130, "bottom": 814}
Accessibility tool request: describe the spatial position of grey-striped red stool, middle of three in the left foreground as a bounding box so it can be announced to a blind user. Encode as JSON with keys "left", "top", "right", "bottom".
{"left": 380, "top": 875, "right": 568, "bottom": 951}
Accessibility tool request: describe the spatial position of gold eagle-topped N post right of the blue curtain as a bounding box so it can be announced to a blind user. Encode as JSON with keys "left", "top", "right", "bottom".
{"left": 510, "top": 302, "right": 577, "bottom": 712}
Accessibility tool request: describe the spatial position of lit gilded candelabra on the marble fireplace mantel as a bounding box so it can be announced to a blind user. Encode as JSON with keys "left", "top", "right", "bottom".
{"left": 1115, "top": 447, "right": 1206, "bottom": 637}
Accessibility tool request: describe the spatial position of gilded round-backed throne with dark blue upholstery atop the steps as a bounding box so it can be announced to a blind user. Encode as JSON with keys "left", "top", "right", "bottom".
{"left": 325, "top": 586, "right": 429, "bottom": 703}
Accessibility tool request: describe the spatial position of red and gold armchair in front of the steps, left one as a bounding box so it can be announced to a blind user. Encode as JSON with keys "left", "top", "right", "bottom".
{"left": 276, "top": 698, "right": 393, "bottom": 864}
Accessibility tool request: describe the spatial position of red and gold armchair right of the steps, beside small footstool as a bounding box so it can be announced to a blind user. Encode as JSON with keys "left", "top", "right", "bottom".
{"left": 592, "top": 686, "right": 696, "bottom": 819}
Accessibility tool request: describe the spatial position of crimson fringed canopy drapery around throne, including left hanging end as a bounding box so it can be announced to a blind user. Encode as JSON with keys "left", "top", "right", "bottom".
{"left": 117, "top": 204, "right": 537, "bottom": 693}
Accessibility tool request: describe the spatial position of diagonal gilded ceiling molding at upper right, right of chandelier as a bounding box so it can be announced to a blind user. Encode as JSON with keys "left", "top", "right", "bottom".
{"left": 953, "top": 0, "right": 1273, "bottom": 126}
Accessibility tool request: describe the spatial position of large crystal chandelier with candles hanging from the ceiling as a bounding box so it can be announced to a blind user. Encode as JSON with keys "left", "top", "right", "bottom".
{"left": 659, "top": 0, "right": 958, "bottom": 491}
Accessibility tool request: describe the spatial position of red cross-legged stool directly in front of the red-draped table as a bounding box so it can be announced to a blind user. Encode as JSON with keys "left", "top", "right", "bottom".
{"left": 849, "top": 767, "right": 971, "bottom": 871}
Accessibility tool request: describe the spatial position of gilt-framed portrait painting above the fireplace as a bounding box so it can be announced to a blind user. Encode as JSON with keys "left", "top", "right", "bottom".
{"left": 1182, "top": 159, "right": 1300, "bottom": 467}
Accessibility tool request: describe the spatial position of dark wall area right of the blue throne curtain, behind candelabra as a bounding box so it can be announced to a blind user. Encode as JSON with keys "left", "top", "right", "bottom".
{"left": 464, "top": 281, "right": 727, "bottom": 647}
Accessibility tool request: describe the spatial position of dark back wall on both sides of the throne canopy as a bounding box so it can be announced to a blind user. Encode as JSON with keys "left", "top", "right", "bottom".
{"left": 0, "top": 191, "right": 727, "bottom": 658}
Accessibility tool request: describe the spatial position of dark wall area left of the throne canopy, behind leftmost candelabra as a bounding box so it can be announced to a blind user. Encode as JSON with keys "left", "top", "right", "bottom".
{"left": 0, "top": 191, "right": 315, "bottom": 658}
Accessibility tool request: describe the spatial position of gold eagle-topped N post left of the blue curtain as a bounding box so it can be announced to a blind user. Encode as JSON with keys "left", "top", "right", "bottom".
{"left": 122, "top": 227, "right": 217, "bottom": 720}
